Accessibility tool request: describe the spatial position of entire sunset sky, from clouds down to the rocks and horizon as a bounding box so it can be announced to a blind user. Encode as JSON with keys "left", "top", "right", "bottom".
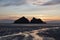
{"left": 0, "top": 0, "right": 60, "bottom": 23}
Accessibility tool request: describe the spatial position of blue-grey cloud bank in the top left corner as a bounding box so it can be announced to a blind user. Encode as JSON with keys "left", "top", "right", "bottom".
{"left": 0, "top": 0, "right": 25, "bottom": 6}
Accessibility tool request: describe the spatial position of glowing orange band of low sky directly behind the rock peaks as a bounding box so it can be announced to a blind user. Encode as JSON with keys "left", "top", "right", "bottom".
{"left": 0, "top": 15, "right": 60, "bottom": 21}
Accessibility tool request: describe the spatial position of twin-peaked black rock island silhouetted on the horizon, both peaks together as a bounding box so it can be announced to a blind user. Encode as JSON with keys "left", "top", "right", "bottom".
{"left": 14, "top": 16, "right": 46, "bottom": 24}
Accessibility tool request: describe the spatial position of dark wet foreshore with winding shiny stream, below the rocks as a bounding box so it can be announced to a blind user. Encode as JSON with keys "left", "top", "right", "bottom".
{"left": 0, "top": 23, "right": 60, "bottom": 40}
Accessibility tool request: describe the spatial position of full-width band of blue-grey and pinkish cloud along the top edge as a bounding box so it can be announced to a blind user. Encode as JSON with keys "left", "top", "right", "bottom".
{"left": 0, "top": 0, "right": 60, "bottom": 7}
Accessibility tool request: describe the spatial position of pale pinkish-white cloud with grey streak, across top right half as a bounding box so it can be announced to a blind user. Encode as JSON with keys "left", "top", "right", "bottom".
{"left": 27, "top": 0, "right": 60, "bottom": 6}
